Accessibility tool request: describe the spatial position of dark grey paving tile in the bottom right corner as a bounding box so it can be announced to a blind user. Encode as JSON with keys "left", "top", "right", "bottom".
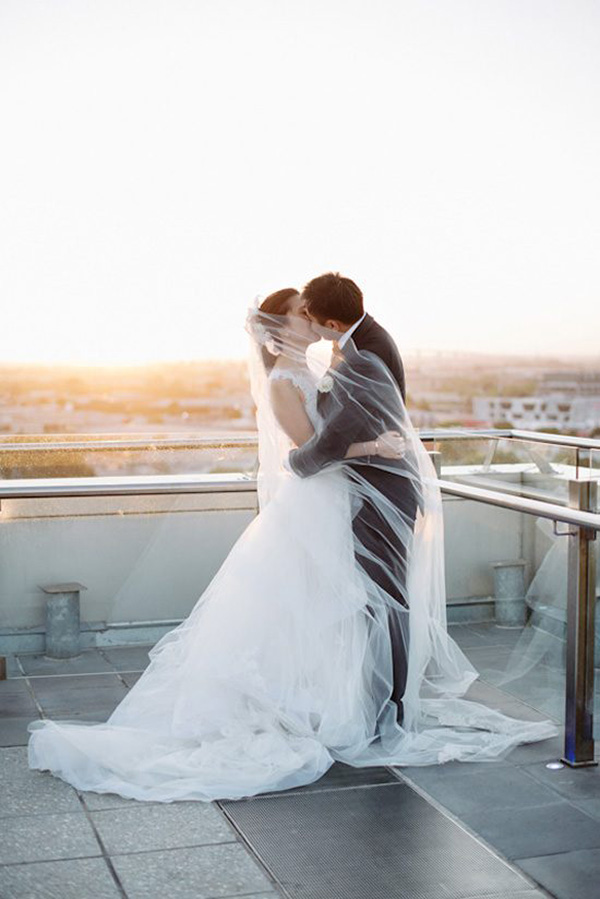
{"left": 518, "top": 849, "right": 600, "bottom": 899}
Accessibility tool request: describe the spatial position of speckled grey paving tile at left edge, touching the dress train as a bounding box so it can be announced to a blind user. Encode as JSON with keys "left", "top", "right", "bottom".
{"left": 0, "top": 746, "right": 83, "bottom": 820}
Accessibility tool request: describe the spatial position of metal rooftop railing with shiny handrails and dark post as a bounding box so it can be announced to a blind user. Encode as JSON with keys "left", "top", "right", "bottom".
{"left": 0, "top": 429, "right": 600, "bottom": 767}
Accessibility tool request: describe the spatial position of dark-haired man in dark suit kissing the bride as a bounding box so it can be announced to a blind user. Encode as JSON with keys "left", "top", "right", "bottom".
{"left": 288, "top": 272, "right": 418, "bottom": 724}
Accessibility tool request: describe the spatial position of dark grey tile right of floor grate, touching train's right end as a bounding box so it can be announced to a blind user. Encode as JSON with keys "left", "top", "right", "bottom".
{"left": 404, "top": 764, "right": 556, "bottom": 818}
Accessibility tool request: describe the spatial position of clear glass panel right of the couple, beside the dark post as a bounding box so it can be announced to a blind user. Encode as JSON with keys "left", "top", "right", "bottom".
{"left": 444, "top": 497, "right": 567, "bottom": 736}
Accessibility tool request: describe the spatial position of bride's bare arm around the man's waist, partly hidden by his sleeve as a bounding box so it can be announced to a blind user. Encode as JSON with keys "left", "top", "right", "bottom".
{"left": 271, "top": 378, "right": 401, "bottom": 459}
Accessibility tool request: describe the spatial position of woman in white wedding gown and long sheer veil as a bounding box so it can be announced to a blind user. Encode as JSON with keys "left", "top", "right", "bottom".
{"left": 28, "top": 290, "right": 558, "bottom": 802}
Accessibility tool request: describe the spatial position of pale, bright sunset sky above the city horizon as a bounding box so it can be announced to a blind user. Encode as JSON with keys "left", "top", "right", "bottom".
{"left": 0, "top": 0, "right": 600, "bottom": 364}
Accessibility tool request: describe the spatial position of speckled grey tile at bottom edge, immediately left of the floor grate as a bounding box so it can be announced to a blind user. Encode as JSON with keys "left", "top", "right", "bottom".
{"left": 112, "top": 843, "right": 277, "bottom": 899}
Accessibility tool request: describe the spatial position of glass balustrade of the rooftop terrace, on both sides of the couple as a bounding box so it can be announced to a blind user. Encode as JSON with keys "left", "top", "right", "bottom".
{"left": 0, "top": 434, "right": 600, "bottom": 768}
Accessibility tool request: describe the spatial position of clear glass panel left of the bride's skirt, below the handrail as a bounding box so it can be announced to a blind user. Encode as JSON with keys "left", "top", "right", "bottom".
{"left": 0, "top": 486, "right": 257, "bottom": 684}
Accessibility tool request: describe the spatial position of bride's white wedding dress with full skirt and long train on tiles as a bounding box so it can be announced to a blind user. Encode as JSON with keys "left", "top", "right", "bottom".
{"left": 28, "top": 371, "right": 557, "bottom": 802}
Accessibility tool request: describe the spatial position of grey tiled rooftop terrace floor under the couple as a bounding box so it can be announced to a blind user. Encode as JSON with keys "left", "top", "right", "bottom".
{"left": 0, "top": 624, "right": 600, "bottom": 899}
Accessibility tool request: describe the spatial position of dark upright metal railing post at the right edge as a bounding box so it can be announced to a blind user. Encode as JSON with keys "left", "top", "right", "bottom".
{"left": 563, "top": 481, "right": 598, "bottom": 768}
